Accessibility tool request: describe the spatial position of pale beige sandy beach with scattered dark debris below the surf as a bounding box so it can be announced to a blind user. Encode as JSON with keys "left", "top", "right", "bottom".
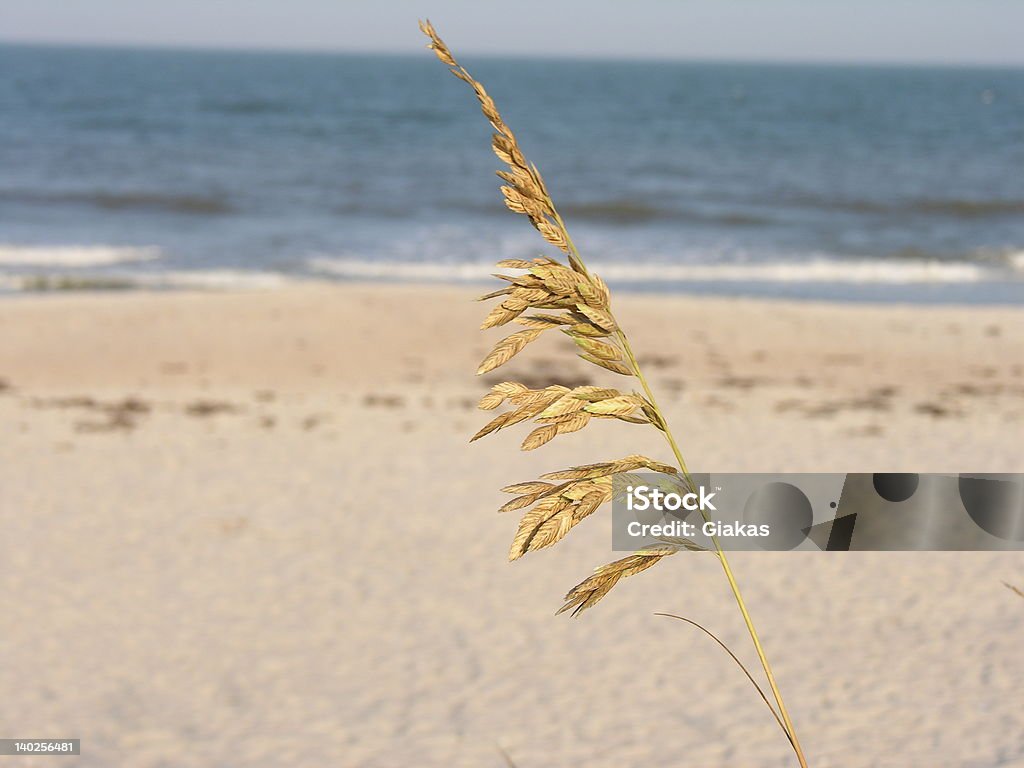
{"left": 0, "top": 286, "right": 1024, "bottom": 768}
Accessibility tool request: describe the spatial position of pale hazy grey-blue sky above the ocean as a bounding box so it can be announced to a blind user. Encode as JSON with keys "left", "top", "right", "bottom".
{"left": 0, "top": 0, "right": 1024, "bottom": 66}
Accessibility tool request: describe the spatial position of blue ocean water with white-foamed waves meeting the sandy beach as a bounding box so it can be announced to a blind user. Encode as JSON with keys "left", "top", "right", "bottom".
{"left": 0, "top": 45, "right": 1024, "bottom": 303}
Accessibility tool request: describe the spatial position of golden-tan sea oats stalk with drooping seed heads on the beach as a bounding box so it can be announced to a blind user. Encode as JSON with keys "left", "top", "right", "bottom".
{"left": 420, "top": 22, "right": 807, "bottom": 768}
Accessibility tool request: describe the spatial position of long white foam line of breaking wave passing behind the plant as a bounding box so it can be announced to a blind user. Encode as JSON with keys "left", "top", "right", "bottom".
{"left": 308, "top": 254, "right": 1003, "bottom": 285}
